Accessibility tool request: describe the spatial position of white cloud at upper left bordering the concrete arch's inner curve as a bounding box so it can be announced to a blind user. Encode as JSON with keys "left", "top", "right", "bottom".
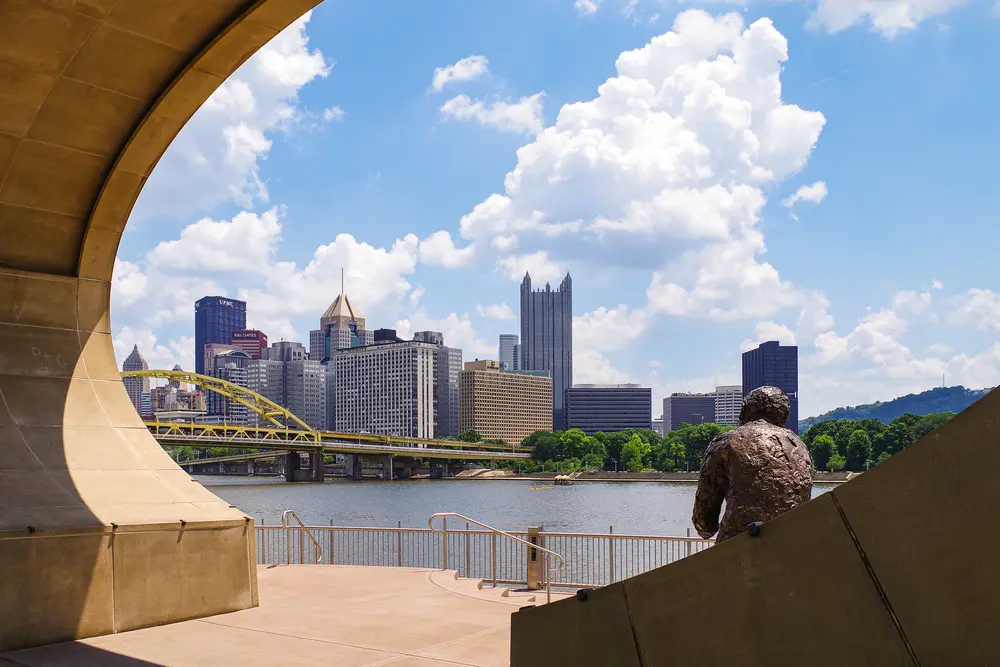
{"left": 127, "top": 13, "right": 339, "bottom": 218}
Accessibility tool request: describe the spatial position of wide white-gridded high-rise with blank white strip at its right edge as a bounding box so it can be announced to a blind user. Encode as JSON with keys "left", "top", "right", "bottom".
{"left": 330, "top": 341, "right": 436, "bottom": 438}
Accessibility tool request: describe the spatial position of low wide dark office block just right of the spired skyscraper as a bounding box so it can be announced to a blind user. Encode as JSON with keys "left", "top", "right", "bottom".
{"left": 566, "top": 384, "right": 653, "bottom": 435}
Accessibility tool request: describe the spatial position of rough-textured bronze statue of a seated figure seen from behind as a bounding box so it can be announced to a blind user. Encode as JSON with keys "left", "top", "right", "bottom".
{"left": 691, "top": 387, "right": 812, "bottom": 542}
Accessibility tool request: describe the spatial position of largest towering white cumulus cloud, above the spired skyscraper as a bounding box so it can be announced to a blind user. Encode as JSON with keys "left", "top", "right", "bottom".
{"left": 461, "top": 10, "right": 826, "bottom": 320}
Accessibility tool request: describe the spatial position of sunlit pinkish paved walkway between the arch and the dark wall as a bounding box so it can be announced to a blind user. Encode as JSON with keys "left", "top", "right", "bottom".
{"left": 0, "top": 565, "right": 518, "bottom": 667}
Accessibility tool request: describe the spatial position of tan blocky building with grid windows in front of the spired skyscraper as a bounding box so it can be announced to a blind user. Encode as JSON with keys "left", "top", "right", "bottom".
{"left": 458, "top": 361, "right": 552, "bottom": 445}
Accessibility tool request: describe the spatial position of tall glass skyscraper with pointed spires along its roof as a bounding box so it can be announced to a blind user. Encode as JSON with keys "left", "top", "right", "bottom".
{"left": 520, "top": 273, "right": 573, "bottom": 429}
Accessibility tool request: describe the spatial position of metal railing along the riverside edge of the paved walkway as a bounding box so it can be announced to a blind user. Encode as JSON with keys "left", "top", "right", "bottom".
{"left": 257, "top": 523, "right": 714, "bottom": 588}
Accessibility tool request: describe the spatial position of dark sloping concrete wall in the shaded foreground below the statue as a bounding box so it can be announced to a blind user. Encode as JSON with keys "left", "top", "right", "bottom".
{"left": 511, "top": 391, "right": 1000, "bottom": 667}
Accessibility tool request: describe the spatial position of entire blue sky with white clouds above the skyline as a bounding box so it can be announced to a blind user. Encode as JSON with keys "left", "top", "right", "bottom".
{"left": 112, "top": 0, "right": 1000, "bottom": 416}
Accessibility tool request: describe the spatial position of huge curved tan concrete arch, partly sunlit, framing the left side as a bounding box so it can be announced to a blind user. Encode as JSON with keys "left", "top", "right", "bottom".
{"left": 0, "top": 0, "right": 319, "bottom": 651}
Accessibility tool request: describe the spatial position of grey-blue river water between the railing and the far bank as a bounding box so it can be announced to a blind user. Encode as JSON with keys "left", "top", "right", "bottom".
{"left": 203, "top": 475, "right": 832, "bottom": 536}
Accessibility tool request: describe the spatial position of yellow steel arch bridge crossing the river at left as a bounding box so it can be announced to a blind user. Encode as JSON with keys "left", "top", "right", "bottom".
{"left": 121, "top": 370, "right": 531, "bottom": 477}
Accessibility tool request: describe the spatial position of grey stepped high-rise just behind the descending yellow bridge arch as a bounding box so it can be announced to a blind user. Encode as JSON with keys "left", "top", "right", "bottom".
{"left": 247, "top": 340, "right": 329, "bottom": 429}
